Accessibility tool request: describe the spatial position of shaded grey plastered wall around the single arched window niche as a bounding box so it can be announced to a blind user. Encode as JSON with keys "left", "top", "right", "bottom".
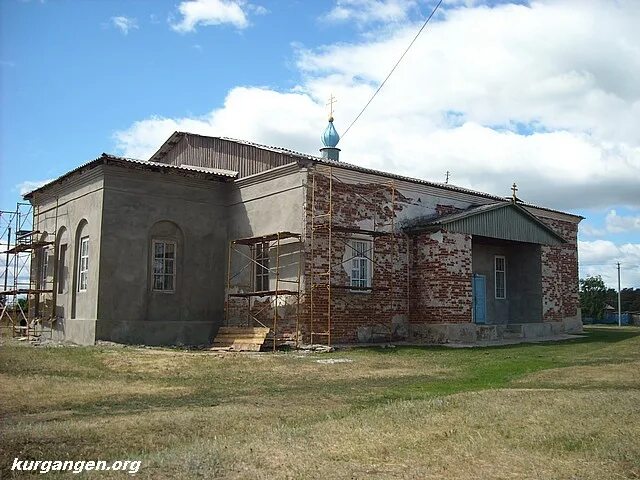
{"left": 96, "top": 167, "right": 231, "bottom": 345}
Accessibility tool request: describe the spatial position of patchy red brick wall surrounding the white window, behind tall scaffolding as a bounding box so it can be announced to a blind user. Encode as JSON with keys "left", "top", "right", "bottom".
{"left": 302, "top": 174, "right": 408, "bottom": 343}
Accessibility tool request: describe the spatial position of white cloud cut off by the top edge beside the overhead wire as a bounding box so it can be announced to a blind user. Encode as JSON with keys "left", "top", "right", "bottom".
{"left": 323, "top": 0, "right": 418, "bottom": 26}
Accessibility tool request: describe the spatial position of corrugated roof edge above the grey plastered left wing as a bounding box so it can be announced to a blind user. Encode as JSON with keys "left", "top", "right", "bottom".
{"left": 24, "top": 153, "right": 237, "bottom": 199}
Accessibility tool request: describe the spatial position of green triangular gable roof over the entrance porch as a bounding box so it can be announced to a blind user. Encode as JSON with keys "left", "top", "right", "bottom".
{"left": 408, "top": 202, "right": 566, "bottom": 245}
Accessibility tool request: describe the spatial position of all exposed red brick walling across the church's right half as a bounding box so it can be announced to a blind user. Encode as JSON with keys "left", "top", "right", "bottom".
{"left": 222, "top": 167, "right": 578, "bottom": 343}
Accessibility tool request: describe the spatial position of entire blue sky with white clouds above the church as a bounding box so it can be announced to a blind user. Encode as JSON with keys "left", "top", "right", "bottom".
{"left": 0, "top": 0, "right": 640, "bottom": 288}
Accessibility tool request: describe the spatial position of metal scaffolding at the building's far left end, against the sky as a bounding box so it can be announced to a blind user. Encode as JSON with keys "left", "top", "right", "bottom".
{"left": 0, "top": 202, "right": 57, "bottom": 339}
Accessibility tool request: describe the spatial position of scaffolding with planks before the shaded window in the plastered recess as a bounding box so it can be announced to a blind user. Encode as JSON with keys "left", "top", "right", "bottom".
{"left": 225, "top": 232, "right": 303, "bottom": 351}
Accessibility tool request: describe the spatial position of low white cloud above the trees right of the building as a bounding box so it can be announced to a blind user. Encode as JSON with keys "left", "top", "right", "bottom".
{"left": 578, "top": 240, "right": 640, "bottom": 288}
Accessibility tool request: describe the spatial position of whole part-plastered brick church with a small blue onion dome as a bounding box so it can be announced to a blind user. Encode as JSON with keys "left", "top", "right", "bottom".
{"left": 26, "top": 122, "right": 582, "bottom": 345}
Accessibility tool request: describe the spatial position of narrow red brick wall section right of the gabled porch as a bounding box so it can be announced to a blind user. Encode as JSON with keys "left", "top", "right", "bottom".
{"left": 539, "top": 217, "right": 580, "bottom": 322}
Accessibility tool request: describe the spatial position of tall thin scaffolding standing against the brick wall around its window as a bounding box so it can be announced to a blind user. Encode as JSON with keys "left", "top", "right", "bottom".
{"left": 308, "top": 165, "right": 397, "bottom": 346}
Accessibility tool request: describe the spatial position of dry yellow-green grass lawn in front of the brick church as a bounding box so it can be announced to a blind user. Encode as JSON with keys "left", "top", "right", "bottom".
{"left": 0, "top": 327, "right": 640, "bottom": 480}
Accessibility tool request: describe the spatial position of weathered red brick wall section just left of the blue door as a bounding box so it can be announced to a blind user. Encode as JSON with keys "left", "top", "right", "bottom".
{"left": 410, "top": 232, "right": 472, "bottom": 323}
